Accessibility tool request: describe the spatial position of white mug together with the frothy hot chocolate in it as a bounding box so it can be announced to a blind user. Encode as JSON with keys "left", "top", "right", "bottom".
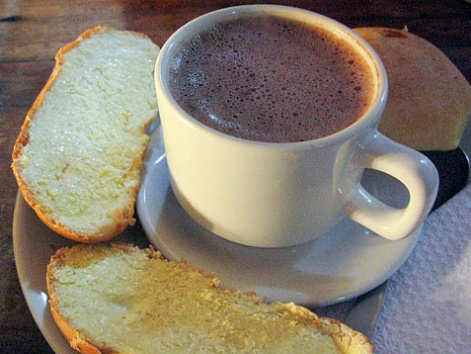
{"left": 155, "top": 5, "right": 438, "bottom": 247}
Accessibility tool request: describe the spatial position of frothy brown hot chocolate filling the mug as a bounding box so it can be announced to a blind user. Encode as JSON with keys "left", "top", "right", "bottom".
{"left": 170, "top": 15, "right": 376, "bottom": 142}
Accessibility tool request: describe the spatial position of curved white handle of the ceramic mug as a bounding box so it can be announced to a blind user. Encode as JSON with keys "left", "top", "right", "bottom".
{"left": 343, "top": 130, "right": 438, "bottom": 240}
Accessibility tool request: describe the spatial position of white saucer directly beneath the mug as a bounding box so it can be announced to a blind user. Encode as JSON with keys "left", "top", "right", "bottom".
{"left": 137, "top": 127, "right": 420, "bottom": 307}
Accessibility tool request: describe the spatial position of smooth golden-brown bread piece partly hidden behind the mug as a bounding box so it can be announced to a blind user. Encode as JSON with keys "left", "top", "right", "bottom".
{"left": 354, "top": 27, "right": 471, "bottom": 151}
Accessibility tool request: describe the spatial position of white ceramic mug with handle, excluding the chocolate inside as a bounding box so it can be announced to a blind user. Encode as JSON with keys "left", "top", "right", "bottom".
{"left": 155, "top": 5, "right": 438, "bottom": 247}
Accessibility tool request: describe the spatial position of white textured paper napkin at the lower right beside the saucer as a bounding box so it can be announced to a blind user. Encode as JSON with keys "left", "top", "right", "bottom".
{"left": 372, "top": 185, "right": 471, "bottom": 354}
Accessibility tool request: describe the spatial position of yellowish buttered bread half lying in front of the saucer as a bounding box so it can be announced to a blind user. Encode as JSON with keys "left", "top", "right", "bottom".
{"left": 47, "top": 243, "right": 373, "bottom": 353}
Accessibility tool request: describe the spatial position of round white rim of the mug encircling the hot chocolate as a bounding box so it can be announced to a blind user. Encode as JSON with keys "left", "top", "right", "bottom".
{"left": 154, "top": 4, "right": 388, "bottom": 148}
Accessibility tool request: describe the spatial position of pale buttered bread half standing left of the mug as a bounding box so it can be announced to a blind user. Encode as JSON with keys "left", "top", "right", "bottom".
{"left": 12, "top": 27, "right": 159, "bottom": 242}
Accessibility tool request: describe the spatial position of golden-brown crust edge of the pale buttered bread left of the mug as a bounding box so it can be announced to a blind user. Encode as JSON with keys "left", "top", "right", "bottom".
{"left": 12, "top": 26, "right": 159, "bottom": 243}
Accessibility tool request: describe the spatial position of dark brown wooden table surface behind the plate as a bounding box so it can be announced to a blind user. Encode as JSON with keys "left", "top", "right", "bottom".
{"left": 0, "top": 0, "right": 471, "bottom": 353}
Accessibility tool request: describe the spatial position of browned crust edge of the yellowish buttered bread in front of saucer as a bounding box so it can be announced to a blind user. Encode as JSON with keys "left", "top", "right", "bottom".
{"left": 46, "top": 242, "right": 374, "bottom": 354}
